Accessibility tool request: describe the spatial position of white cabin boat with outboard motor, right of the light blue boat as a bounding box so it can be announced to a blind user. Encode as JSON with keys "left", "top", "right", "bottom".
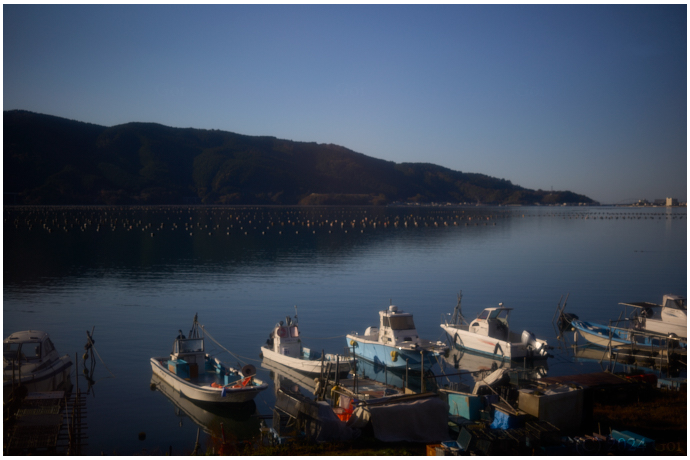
{"left": 441, "top": 294, "right": 549, "bottom": 360}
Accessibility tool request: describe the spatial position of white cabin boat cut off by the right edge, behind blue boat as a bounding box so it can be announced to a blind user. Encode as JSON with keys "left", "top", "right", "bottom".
{"left": 621, "top": 294, "right": 688, "bottom": 339}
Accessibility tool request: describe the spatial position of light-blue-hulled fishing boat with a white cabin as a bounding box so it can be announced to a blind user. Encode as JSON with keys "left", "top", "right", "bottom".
{"left": 345, "top": 305, "right": 448, "bottom": 370}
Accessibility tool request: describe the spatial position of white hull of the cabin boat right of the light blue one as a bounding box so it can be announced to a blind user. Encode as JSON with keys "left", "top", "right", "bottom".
{"left": 441, "top": 324, "right": 546, "bottom": 361}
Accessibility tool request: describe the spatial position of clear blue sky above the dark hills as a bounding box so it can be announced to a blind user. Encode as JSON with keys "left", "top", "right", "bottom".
{"left": 3, "top": 4, "right": 688, "bottom": 203}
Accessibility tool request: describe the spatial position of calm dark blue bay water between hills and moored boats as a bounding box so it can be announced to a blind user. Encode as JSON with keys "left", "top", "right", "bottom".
{"left": 3, "top": 207, "right": 687, "bottom": 455}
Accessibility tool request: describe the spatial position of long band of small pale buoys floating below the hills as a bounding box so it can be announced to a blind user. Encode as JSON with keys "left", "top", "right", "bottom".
{"left": 5, "top": 206, "right": 685, "bottom": 237}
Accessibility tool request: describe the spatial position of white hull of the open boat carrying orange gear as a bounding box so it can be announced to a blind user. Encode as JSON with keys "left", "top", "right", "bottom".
{"left": 151, "top": 357, "right": 268, "bottom": 404}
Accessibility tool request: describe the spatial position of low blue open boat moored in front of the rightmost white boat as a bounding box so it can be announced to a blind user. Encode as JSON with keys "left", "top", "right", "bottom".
{"left": 570, "top": 319, "right": 687, "bottom": 354}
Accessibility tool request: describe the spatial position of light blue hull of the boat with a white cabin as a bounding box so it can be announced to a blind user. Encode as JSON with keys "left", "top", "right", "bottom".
{"left": 346, "top": 335, "right": 438, "bottom": 370}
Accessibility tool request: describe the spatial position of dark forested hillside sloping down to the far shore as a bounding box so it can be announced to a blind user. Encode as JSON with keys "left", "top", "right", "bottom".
{"left": 3, "top": 110, "right": 592, "bottom": 205}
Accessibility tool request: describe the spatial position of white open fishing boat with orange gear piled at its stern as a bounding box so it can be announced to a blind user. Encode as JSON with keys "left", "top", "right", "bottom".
{"left": 151, "top": 315, "right": 268, "bottom": 403}
